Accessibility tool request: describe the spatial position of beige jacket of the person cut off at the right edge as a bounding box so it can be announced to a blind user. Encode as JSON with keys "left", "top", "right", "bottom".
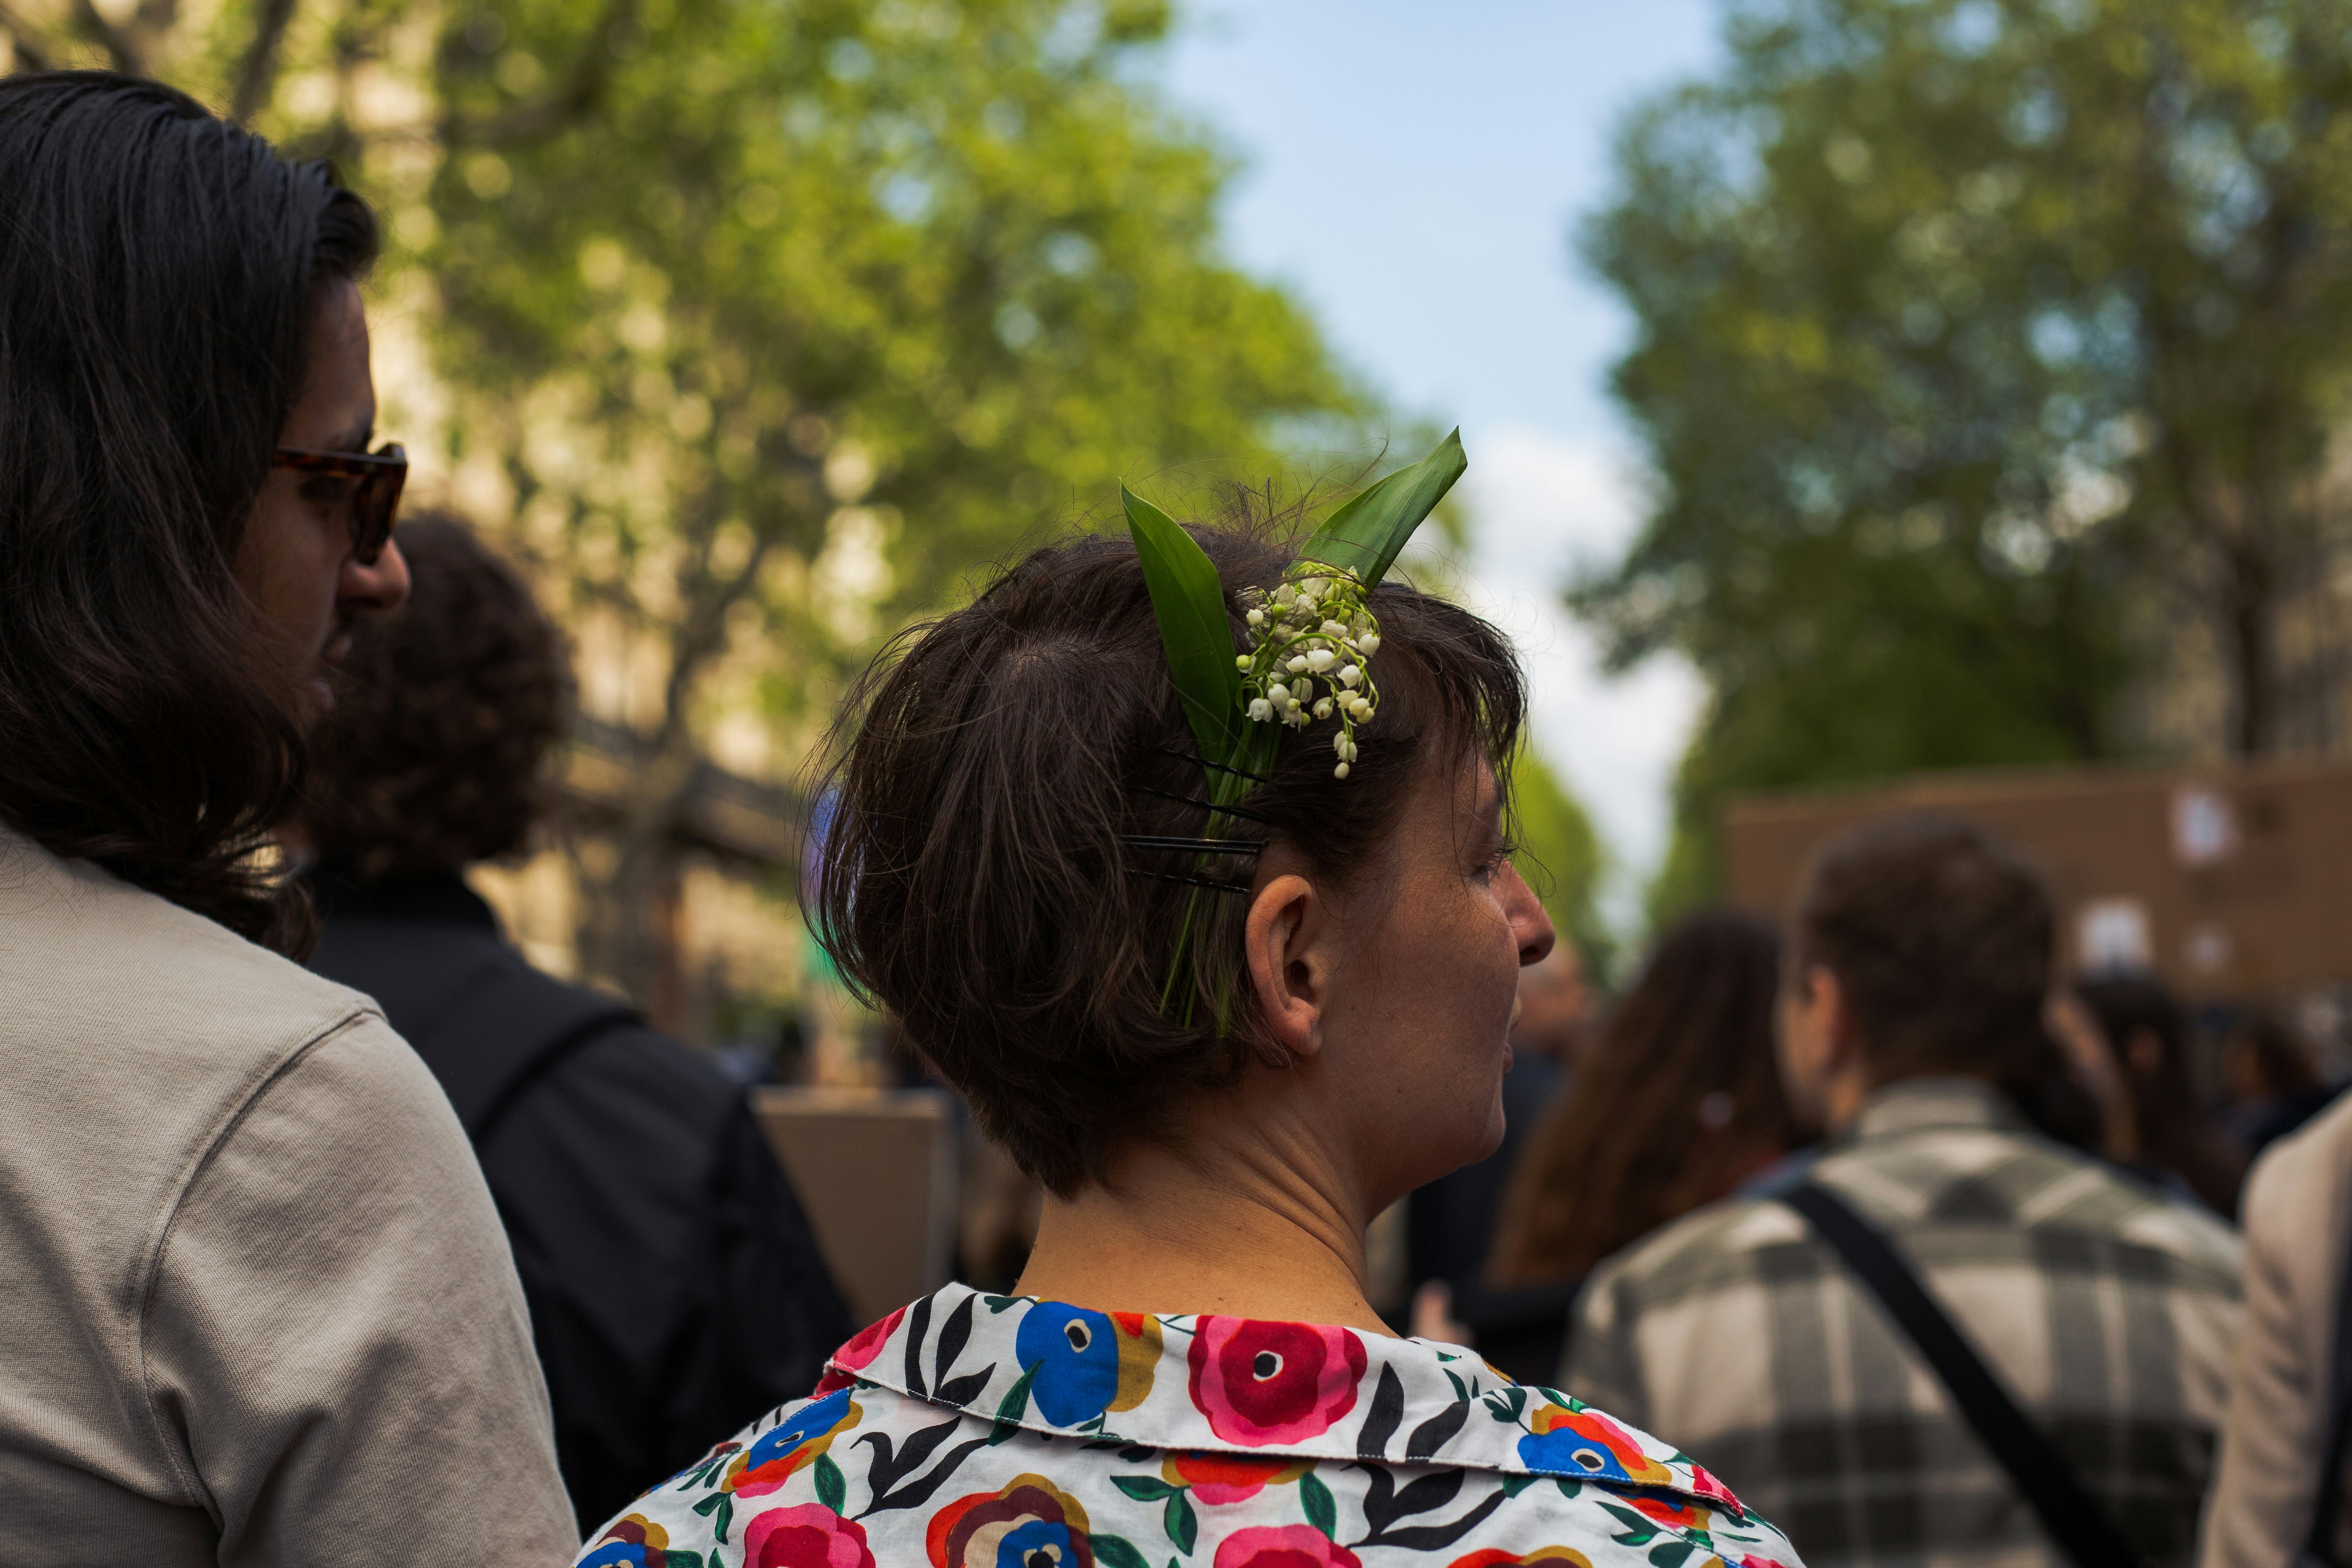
{"left": 2204, "top": 1096, "right": 2352, "bottom": 1568}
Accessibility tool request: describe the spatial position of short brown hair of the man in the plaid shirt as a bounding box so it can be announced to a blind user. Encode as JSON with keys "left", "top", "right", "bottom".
{"left": 1795, "top": 811, "right": 2056, "bottom": 1084}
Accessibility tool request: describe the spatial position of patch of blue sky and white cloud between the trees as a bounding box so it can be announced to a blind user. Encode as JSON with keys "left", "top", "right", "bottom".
{"left": 1164, "top": 0, "right": 1719, "bottom": 919}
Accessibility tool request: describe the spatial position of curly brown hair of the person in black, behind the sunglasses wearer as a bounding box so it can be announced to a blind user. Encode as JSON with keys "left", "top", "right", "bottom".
{"left": 301, "top": 512, "right": 572, "bottom": 882}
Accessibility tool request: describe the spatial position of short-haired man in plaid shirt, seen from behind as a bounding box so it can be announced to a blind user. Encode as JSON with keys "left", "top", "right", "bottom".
{"left": 1562, "top": 816, "right": 2239, "bottom": 1568}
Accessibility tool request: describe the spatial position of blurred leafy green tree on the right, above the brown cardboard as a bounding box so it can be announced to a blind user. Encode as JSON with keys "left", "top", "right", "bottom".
{"left": 1571, "top": 0, "right": 2352, "bottom": 907}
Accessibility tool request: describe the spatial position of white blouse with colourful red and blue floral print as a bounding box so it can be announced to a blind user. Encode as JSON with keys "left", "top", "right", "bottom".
{"left": 579, "top": 1286, "right": 1797, "bottom": 1568}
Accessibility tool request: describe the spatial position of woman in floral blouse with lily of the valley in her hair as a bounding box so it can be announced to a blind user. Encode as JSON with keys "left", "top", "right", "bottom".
{"left": 581, "top": 442, "right": 1792, "bottom": 1568}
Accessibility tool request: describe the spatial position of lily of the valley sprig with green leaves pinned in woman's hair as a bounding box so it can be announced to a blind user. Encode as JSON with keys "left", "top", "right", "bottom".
{"left": 1120, "top": 430, "right": 1470, "bottom": 1034}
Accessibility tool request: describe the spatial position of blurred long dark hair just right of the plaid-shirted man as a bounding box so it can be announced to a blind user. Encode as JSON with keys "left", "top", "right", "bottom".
{"left": 2072, "top": 976, "right": 2246, "bottom": 1220}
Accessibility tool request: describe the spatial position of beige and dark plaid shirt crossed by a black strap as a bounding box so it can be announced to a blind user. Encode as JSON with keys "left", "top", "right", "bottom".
{"left": 1562, "top": 1079, "right": 2239, "bottom": 1568}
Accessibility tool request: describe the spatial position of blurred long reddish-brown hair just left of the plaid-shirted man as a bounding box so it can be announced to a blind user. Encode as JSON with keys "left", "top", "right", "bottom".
{"left": 1489, "top": 912, "right": 1799, "bottom": 1286}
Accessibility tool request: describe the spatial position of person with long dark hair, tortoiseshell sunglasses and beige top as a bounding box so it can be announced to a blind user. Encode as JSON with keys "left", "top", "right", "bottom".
{"left": 0, "top": 73, "right": 576, "bottom": 1566}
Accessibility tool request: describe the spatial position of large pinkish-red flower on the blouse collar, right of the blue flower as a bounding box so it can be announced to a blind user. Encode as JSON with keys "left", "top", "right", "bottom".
{"left": 1188, "top": 1316, "right": 1364, "bottom": 1448}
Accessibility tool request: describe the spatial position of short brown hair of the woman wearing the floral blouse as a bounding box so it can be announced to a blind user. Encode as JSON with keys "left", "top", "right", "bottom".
{"left": 807, "top": 519, "right": 1524, "bottom": 1194}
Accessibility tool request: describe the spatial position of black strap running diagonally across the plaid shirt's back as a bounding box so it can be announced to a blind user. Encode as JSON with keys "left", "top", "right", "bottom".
{"left": 1780, "top": 1183, "right": 2143, "bottom": 1568}
